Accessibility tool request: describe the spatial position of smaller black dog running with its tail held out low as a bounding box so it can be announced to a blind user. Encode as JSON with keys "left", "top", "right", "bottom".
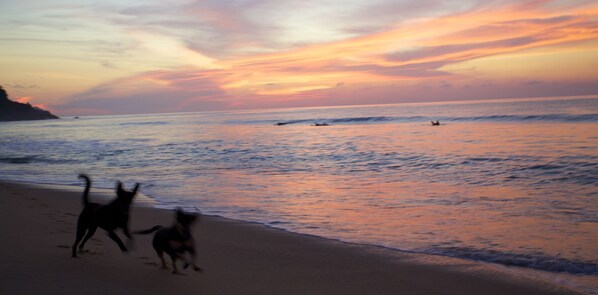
{"left": 135, "top": 208, "right": 202, "bottom": 274}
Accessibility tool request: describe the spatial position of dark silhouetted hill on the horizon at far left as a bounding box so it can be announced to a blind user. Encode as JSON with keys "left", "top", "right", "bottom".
{"left": 0, "top": 86, "right": 59, "bottom": 121}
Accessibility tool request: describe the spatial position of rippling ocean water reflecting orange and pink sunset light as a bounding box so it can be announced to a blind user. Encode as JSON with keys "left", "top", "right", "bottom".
{"left": 0, "top": 98, "right": 598, "bottom": 293}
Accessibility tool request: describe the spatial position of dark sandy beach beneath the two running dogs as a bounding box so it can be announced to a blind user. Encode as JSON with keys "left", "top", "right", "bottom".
{"left": 0, "top": 182, "right": 576, "bottom": 295}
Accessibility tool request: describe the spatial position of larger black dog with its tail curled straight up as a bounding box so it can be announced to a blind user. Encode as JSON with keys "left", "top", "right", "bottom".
{"left": 73, "top": 174, "right": 139, "bottom": 257}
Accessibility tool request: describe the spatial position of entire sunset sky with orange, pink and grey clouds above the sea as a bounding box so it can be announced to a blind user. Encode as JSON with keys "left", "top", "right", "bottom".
{"left": 0, "top": 0, "right": 598, "bottom": 115}
